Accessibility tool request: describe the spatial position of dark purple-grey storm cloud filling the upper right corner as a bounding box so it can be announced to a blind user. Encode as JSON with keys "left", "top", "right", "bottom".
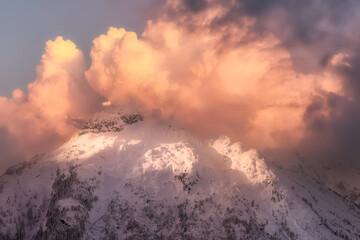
{"left": 167, "top": 0, "right": 360, "bottom": 72}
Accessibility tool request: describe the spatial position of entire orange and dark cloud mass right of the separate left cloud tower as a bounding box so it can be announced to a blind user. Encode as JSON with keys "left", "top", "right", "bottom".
{"left": 86, "top": 0, "right": 360, "bottom": 167}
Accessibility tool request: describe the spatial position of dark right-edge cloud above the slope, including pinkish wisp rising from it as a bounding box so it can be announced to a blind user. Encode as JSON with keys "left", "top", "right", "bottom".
{"left": 300, "top": 48, "right": 360, "bottom": 165}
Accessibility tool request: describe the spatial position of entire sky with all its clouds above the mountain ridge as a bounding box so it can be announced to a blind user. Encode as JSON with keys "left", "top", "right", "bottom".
{"left": 0, "top": 0, "right": 360, "bottom": 173}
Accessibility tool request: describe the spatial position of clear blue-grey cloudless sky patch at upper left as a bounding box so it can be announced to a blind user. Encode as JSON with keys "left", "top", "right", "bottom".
{"left": 0, "top": 0, "right": 149, "bottom": 97}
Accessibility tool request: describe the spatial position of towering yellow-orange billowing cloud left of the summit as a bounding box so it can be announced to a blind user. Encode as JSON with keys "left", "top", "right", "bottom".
{"left": 0, "top": 37, "right": 101, "bottom": 168}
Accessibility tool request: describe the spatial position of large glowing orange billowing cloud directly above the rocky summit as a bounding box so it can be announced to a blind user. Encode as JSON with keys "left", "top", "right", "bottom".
{"left": 86, "top": 18, "right": 342, "bottom": 152}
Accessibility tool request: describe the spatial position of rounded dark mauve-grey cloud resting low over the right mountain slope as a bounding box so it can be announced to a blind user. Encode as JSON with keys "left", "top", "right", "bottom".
{"left": 299, "top": 94, "right": 360, "bottom": 164}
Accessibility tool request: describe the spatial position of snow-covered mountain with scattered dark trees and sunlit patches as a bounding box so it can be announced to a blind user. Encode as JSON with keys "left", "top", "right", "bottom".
{"left": 0, "top": 109, "right": 360, "bottom": 239}
